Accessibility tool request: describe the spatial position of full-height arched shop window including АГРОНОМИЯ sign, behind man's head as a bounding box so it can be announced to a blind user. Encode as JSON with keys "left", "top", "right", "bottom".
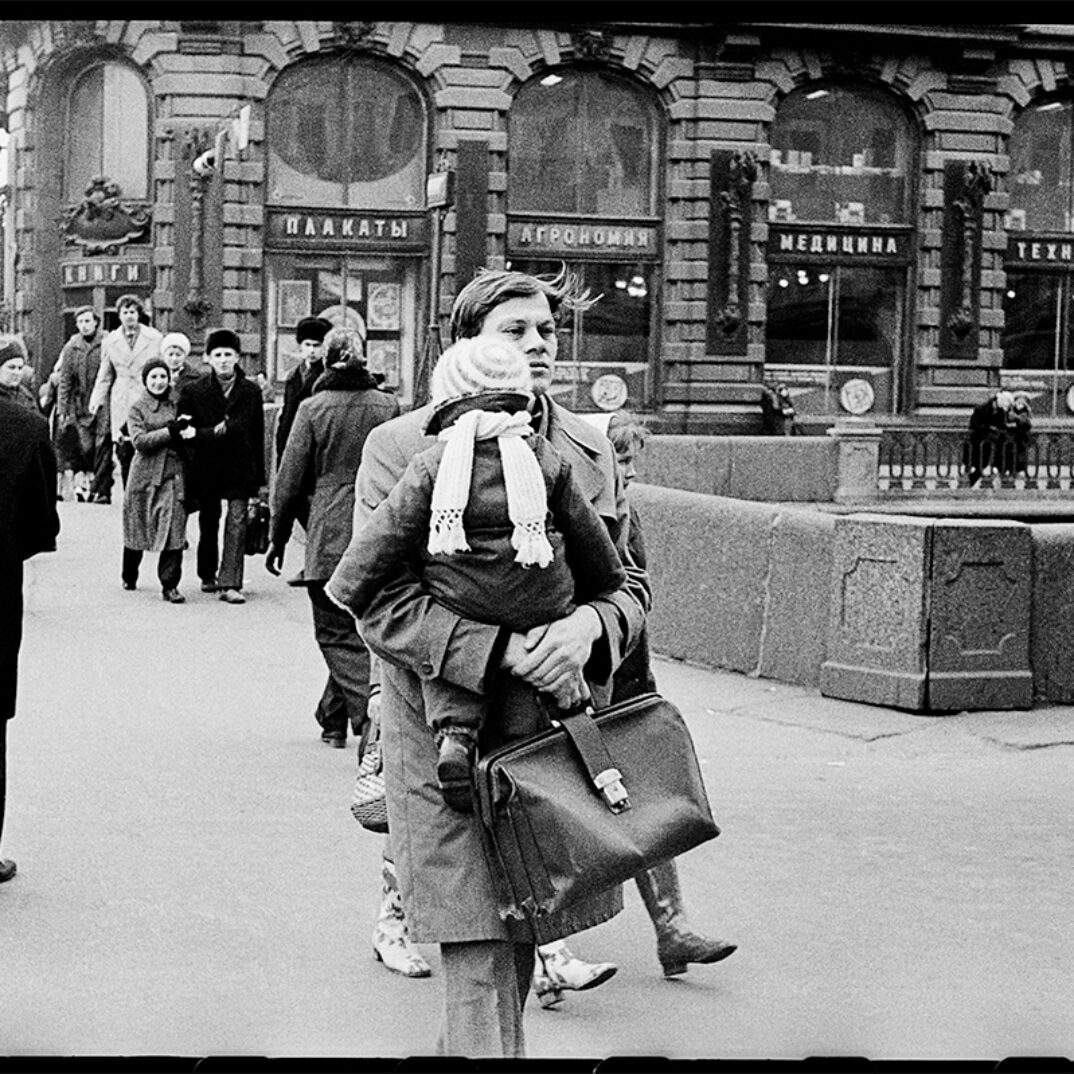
{"left": 507, "top": 68, "right": 663, "bottom": 410}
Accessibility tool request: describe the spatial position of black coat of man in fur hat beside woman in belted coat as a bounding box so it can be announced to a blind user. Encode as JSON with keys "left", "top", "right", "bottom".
{"left": 178, "top": 368, "right": 265, "bottom": 510}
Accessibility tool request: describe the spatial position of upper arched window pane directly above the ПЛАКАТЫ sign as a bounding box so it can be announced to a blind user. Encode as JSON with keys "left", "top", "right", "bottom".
{"left": 267, "top": 57, "right": 426, "bottom": 209}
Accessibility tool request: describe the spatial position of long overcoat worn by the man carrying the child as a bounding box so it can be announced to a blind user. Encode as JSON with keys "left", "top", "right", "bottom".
{"left": 326, "top": 403, "right": 650, "bottom": 943}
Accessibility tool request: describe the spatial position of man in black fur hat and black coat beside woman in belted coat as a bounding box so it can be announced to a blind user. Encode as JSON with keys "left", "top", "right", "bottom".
{"left": 178, "top": 329, "right": 267, "bottom": 604}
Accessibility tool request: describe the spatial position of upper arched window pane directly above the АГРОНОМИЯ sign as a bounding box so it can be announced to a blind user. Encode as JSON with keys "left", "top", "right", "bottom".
{"left": 508, "top": 70, "right": 659, "bottom": 217}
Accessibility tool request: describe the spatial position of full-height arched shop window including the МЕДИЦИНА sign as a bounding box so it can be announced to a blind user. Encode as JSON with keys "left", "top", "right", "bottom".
{"left": 765, "top": 86, "right": 917, "bottom": 415}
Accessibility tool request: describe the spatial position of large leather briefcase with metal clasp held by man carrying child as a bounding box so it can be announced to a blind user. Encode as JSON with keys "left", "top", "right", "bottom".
{"left": 475, "top": 694, "right": 720, "bottom": 919}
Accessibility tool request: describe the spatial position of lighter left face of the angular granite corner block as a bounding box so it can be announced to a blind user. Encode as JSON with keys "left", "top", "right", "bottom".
{"left": 819, "top": 514, "right": 932, "bottom": 712}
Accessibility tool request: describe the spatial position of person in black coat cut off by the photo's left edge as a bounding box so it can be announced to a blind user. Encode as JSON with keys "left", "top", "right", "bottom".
{"left": 0, "top": 400, "right": 60, "bottom": 883}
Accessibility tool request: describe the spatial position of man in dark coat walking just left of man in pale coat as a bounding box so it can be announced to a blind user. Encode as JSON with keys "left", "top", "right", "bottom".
{"left": 56, "top": 306, "right": 112, "bottom": 502}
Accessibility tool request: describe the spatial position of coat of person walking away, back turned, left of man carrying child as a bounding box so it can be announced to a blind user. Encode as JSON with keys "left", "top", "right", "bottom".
{"left": 272, "top": 364, "right": 400, "bottom": 583}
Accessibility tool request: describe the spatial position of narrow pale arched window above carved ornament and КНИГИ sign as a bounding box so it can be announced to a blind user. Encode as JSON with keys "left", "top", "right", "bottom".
{"left": 63, "top": 62, "right": 149, "bottom": 204}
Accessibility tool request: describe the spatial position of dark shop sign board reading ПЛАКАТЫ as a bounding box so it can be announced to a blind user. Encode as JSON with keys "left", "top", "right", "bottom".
{"left": 266, "top": 209, "right": 429, "bottom": 250}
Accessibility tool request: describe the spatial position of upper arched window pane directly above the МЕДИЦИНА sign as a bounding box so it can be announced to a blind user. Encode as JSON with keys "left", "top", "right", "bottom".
{"left": 769, "top": 86, "right": 915, "bottom": 224}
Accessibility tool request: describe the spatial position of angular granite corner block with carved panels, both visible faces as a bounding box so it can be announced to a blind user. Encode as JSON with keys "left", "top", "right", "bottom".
{"left": 819, "top": 514, "right": 1033, "bottom": 713}
